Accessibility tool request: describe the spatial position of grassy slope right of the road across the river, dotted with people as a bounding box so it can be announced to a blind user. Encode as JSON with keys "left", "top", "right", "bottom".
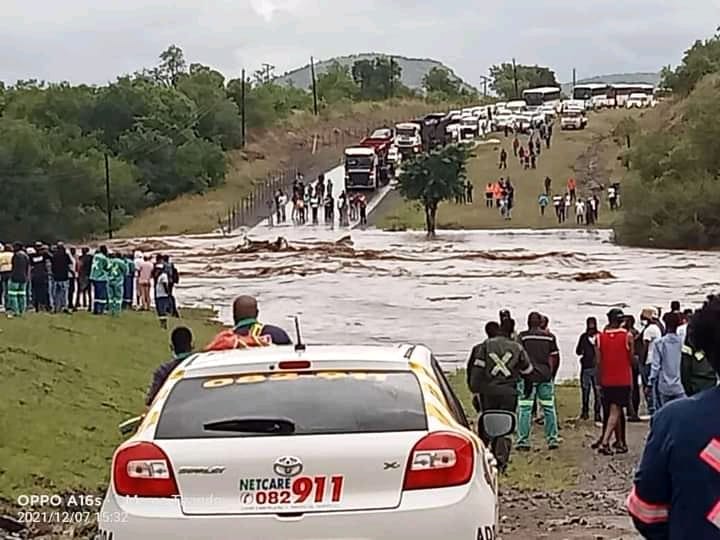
{"left": 371, "top": 109, "right": 637, "bottom": 230}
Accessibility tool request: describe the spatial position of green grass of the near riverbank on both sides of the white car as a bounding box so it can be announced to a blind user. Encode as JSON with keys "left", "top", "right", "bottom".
{"left": 0, "top": 310, "right": 584, "bottom": 502}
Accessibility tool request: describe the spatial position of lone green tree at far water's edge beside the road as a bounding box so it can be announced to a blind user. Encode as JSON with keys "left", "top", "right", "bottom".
{"left": 398, "top": 145, "right": 472, "bottom": 238}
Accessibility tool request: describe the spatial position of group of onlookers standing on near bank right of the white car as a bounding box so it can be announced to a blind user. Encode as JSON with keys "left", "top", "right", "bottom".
{"left": 467, "top": 302, "right": 717, "bottom": 466}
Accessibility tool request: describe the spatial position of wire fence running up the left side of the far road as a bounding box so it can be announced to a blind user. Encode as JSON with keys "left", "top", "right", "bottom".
{"left": 218, "top": 118, "right": 402, "bottom": 234}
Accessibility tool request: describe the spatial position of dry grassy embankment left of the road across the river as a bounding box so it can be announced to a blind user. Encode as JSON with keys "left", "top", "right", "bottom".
{"left": 117, "top": 100, "right": 450, "bottom": 237}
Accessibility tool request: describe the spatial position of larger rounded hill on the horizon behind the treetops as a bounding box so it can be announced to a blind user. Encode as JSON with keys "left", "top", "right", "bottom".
{"left": 275, "top": 53, "right": 471, "bottom": 90}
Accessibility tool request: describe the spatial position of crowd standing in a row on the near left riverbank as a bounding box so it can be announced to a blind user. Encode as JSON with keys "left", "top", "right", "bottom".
{"left": 0, "top": 242, "right": 180, "bottom": 327}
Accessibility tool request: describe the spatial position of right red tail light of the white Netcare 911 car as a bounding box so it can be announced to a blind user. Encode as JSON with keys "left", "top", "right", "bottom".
{"left": 403, "top": 431, "right": 475, "bottom": 490}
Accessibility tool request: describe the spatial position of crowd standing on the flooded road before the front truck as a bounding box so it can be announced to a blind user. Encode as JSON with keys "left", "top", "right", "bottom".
{"left": 267, "top": 174, "right": 368, "bottom": 227}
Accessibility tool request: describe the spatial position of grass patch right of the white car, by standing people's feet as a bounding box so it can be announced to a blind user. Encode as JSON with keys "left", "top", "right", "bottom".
{"left": 449, "top": 370, "right": 591, "bottom": 490}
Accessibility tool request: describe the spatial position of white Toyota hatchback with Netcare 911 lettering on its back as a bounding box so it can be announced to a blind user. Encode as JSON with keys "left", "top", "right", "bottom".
{"left": 97, "top": 345, "right": 514, "bottom": 540}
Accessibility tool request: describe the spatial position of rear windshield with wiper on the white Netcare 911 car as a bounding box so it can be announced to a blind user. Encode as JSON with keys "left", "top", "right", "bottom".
{"left": 155, "top": 371, "right": 427, "bottom": 439}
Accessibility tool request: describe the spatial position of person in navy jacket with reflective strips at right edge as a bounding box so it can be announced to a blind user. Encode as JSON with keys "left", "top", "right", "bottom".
{"left": 627, "top": 295, "right": 720, "bottom": 540}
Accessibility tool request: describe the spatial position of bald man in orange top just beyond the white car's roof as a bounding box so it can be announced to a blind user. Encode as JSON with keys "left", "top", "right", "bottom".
{"left": 205, "top": 296, "right": 292, "bottom": 351}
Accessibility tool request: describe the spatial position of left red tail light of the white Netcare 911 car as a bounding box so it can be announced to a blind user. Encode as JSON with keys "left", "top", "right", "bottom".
{"left": 113, "top": 442, "right": 179, "bottom": 497}
